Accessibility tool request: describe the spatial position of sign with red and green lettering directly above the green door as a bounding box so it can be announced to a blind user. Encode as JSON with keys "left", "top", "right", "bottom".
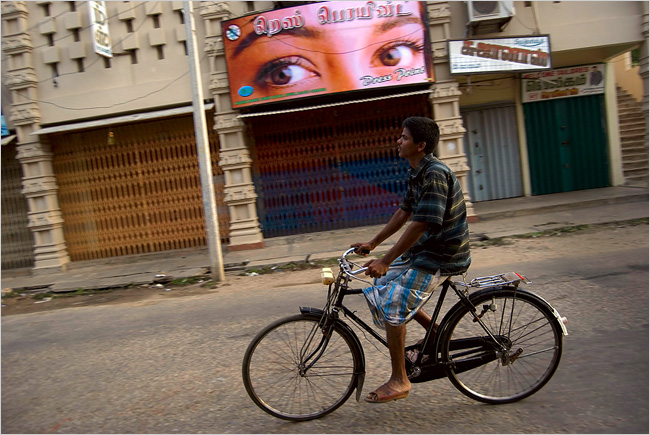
{"left": 521, "top": 63, "right": 605, "bottom": 103}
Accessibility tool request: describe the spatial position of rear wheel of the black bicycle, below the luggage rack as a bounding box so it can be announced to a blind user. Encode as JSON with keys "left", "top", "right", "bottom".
{"left": 440, "top": 288, "right": 563, "bottom": 404}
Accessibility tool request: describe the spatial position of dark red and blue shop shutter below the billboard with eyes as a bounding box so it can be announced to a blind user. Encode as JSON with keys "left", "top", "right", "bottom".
{"left": 251, "top": 95, "right": 431, "bottom": 237}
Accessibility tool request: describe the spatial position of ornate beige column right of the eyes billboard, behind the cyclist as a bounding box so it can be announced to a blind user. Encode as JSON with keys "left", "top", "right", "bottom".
{"left": 427, "top": 2, "right": 478, "bottom": 222}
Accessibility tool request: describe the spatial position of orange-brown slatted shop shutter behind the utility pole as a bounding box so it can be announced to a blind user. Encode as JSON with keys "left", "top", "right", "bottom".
{"left": 48, "top": 116, "right": 229, "bottom": 261}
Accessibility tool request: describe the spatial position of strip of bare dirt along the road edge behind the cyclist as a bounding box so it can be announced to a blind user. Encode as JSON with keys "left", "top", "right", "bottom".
{"left": 2, "top": 219, "right": 648, "bottom": 316}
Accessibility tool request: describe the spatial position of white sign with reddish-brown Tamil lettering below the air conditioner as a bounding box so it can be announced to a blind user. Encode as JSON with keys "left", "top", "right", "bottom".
{"left": 449, "top": 35, "right": 551, "bottom": 74}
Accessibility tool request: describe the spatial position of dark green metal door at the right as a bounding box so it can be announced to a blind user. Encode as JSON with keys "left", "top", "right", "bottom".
{"left": 524, "top": 95, "right": 609, "bottom": 195}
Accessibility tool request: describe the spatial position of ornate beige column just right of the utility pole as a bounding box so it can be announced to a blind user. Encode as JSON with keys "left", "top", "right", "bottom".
{"left": 201, "top": 2, "right": 264, "bottom": 251}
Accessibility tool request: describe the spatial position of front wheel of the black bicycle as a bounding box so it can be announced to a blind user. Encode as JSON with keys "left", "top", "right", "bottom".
{"left": 242, "top": 314, "right": 364, "bottom": 421}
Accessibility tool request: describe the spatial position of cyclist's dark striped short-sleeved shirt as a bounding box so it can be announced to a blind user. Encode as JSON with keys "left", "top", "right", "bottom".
{"left": 400, "top": 154, "right": 471, "bottom": 276}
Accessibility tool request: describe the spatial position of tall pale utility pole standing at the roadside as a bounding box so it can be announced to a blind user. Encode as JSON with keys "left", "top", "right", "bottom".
{"left": 183, "top": 1, "right": 225, "bottom": 282}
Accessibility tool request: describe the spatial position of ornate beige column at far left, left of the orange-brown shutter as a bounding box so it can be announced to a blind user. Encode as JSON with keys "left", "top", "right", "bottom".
{"left": 2, "top": 1, "right": 70, "bottom": 272}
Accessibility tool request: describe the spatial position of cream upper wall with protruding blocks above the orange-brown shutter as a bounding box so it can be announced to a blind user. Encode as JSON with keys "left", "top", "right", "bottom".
{"left": 17, "top": 1, "right": 209, "bottom": 126}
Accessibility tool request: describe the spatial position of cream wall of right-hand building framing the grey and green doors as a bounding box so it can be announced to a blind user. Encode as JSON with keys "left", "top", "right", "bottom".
{"left": 450, "top": 1, "right": 647, "bottom": 195}
